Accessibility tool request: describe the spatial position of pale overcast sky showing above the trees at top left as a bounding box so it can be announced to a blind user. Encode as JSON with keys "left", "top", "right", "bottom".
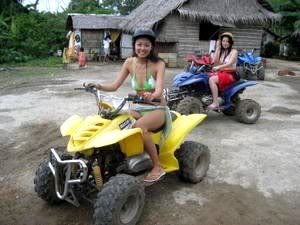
{"left": 23, "top": 0, "right": 70, "bottom": 12}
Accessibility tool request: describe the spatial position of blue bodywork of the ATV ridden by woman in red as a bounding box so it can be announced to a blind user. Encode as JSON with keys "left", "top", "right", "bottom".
{"left": 173, "top": 72, "right": 257, "bottom": 110}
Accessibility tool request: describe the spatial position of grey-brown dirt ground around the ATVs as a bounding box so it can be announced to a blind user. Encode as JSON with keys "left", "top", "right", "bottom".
{"left": 0, "top": 60, "right": 300, "bottom": 225}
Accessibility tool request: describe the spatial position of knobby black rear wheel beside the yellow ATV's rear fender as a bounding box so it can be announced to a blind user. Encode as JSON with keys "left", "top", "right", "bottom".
{"left": 176, "top": 141, "right": 210, "bottom": 183}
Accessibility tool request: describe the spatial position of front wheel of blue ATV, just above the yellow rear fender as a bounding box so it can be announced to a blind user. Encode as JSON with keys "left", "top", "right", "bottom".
{"left": 176, "top": 96, "right": 205, "bottom": 115}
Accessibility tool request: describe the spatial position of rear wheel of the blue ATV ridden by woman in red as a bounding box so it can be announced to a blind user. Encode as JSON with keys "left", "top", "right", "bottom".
{"left": 235, "top": 99, "right": 261, "bottom": 124}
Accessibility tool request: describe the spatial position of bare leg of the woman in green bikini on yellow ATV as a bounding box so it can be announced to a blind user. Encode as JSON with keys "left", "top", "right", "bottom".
{"left": 134, "top": 110, "right": 165, "bottom": 177}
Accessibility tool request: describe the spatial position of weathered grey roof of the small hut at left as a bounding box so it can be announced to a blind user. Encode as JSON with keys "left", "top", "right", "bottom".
{"left": 67, "top": 14, "right": 126, "bottom": 29}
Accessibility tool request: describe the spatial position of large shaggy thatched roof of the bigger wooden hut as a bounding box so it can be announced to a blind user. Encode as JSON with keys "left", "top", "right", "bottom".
{"left": 121, "top": 0, "right": 280, "bottom": 31}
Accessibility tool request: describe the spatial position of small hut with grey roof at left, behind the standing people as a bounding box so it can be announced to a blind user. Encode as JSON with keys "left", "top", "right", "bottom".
{"left": 66, "top": 14, "right": 125, "bottom": 60}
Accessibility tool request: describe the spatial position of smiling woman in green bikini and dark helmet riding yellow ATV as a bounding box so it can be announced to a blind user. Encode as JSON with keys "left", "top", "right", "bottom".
{"left": 89, "top": 29, "right": 166, "bottom": 182}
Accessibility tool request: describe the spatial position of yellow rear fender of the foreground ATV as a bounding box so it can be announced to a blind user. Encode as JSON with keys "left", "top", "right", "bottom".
{"left": 159, "top": 114, "right": 206, "bottom": 172}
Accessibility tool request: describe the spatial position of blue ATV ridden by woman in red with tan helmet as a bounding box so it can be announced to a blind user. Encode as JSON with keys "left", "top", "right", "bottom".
{"left": 164, "top": 72, "right": 261, "bottom": 124}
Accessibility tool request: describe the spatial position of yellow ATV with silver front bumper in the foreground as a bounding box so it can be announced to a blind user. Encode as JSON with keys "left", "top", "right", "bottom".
{"left": 34, "top": 87, "right": 210, "bottom": 225}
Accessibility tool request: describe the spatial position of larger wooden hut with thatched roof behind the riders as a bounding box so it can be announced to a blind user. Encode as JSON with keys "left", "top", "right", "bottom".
{"left": 120, "top": 0, "right": 280, "bottom": 66}
